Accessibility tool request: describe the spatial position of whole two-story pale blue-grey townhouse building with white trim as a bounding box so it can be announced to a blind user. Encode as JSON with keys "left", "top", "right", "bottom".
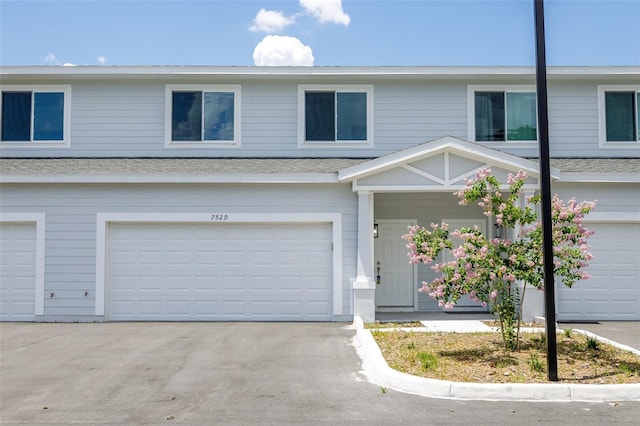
{"left": 0, "top": 67, "right": 640, "bottom": 321}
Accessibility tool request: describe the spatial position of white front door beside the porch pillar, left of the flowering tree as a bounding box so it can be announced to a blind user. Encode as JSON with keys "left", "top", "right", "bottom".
{"left": 373, "top": 220, "right": 416, "bottom": 308}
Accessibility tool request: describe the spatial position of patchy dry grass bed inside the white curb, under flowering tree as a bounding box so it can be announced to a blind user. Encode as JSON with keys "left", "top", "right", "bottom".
{"left": 372, "top": 326, "right": 640, "bottom": 384}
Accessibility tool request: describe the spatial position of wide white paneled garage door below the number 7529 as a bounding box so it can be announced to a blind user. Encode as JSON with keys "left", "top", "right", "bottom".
{"left": 107, "top": 223, "right": 332, "bottom": 321}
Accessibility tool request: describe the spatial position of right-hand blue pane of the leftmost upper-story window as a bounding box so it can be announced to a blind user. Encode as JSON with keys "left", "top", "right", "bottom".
{"left": 33, "top": 92, "right": 64, "bottom": 141}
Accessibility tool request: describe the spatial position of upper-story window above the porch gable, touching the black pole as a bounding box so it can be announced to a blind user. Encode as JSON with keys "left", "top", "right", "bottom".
{"left": 468, "top": 86, "right": 538, "bottom": 144}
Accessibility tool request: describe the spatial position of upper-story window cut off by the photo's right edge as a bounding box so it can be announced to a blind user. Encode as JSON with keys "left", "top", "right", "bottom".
{"left": 598, "top": 86, "right": 640, "bottom": 148}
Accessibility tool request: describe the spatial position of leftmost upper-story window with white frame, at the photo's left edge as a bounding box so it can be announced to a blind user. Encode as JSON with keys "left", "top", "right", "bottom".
{"left": 0, "top": 85, "right": 71, "bottom": 148}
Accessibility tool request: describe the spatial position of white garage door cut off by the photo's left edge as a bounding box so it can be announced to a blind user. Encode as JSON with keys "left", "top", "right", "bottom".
{"left": 0, "top": 223, "right": 36, "bottom": 321}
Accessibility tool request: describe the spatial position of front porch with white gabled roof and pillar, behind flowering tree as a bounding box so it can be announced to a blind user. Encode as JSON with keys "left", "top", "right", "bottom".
{"left": 339, "top": 137, "right": 543, "bottom": 322}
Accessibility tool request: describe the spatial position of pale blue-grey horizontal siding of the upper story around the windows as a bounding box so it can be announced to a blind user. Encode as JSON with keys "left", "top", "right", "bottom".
{"left": 0, "top": 75, "right": 640, "bottom": 158}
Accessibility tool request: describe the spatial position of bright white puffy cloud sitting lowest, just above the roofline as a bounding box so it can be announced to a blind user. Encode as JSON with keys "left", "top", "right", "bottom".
{"left": 253, "top": 35, "right": 315, "bottom": 67}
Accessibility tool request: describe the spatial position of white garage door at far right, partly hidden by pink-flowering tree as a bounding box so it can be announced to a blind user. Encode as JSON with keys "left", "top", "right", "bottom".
{"left": 558, "top": 223, "right": 640, "bottom": 321}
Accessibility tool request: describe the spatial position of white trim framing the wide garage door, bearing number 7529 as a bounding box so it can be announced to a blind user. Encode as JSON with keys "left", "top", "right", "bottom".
{"left": 95, "top": 211, "right": 343, "bottom": 317}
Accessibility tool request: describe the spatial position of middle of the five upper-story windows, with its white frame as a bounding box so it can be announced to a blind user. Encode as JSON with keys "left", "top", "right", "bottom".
{"left": 298, "top": 85, "right": 373, "bottom": 147}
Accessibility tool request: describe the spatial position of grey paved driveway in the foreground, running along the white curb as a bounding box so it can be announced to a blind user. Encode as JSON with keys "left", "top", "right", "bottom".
{"left": 0, "top": 323, "right": 640, "bottom": 425}
